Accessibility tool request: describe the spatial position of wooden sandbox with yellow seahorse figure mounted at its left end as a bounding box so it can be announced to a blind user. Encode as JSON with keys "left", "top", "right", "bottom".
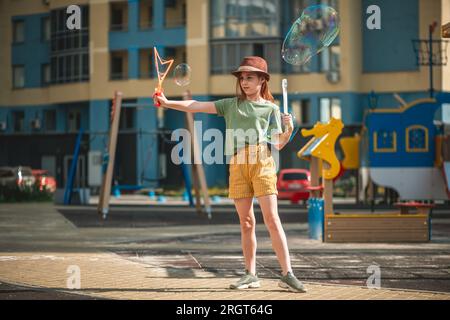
{"left": 297, "top": 119, "right": 432, "bottom": 242}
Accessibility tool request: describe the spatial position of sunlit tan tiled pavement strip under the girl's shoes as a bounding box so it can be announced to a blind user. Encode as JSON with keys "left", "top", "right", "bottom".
{"left": 0, "top": 252, "right": 450, "bottom": 300}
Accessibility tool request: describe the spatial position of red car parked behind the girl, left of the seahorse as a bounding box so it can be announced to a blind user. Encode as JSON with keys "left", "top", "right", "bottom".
{"left": 277, "top": 169, "right": 311, "bottom": 203}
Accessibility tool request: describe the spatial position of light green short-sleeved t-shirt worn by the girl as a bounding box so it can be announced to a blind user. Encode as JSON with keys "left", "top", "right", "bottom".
{"left": 214, "top": 98, "right": 283, "bottom": 155}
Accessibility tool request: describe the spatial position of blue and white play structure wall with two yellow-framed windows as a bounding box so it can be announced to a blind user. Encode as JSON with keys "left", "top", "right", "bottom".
{"left": 360, "top": 93, "right": 450, "bottom": 200}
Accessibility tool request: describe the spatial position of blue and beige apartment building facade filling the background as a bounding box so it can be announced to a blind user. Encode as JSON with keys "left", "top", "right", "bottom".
{"left": 0, "top": 0, "right": 450, "bottom": 192}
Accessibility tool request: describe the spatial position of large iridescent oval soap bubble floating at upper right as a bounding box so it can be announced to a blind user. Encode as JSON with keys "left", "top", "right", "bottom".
{"left": 281, "top": 5, "right": 340, "bottom": 66}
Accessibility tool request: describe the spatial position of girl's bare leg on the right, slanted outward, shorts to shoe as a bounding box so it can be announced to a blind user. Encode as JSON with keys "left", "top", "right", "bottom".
{"left": 258, "top": 195, "right": 292, "bottom": 275}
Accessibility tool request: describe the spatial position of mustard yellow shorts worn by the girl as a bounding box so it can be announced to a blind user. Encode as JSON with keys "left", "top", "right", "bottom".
{"left": 228, "top": 145, "right": 278, "bottom": 199}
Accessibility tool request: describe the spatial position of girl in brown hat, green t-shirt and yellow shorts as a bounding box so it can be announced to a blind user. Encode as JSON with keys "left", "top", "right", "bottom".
{"left": 153, "top": 56, "right": 306, "bottom": 292}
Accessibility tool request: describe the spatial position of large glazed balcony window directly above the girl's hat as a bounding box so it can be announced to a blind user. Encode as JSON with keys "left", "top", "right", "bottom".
{"left": 210, "top": 0, "right": 282, "bottom": 74}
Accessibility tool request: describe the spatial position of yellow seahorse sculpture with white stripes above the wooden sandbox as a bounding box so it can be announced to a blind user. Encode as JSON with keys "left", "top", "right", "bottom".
{"left": 297, "top": 118, "right": 344, "bottom": 180}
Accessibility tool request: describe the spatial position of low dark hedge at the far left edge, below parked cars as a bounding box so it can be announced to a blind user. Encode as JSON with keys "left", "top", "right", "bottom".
{"left": 0, "top": 185, "right": 53, "bottom": 203}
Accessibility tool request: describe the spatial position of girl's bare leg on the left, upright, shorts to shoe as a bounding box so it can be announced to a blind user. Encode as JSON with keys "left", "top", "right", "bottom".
{"left": 234, "top": 198, "right": 256, "bottom": 274}
